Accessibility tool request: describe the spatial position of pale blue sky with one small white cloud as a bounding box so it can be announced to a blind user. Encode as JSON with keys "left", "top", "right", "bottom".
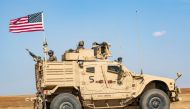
{"left": 0, "top": 0, "right": 190, "bottom": 95}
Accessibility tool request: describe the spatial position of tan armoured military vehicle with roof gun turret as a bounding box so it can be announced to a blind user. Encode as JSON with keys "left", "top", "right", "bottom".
{"left": 28, "top": 41, "right": 181, "bottom": 109}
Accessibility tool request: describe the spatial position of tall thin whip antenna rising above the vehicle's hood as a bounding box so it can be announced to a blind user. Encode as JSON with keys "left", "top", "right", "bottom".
{"left": 135, "top": 10, "right": 144, "bottom": 74}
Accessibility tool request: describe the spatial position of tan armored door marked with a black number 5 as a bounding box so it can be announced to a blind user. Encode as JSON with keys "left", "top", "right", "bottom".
{"left": 82, "top": 62, "right": 106, "bottom": 94}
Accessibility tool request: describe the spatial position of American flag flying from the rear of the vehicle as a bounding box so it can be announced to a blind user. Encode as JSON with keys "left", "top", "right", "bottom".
{"left": 9, "top": 12, "right": 44, "bottom": 33}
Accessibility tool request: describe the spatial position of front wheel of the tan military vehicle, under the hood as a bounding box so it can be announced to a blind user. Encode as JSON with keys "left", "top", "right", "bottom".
{"left": 140, "top": 89, "right": 170, "bottom": 109}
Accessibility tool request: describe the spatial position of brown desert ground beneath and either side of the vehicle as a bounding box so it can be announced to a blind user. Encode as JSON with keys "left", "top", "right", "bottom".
{"left": 0, "top": 88, "right": 190, "bottom": 109}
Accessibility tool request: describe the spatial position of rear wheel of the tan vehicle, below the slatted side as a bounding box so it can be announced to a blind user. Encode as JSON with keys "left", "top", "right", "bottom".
{"left": 50, "top": 93, "right": 81, "bottom": 109}
